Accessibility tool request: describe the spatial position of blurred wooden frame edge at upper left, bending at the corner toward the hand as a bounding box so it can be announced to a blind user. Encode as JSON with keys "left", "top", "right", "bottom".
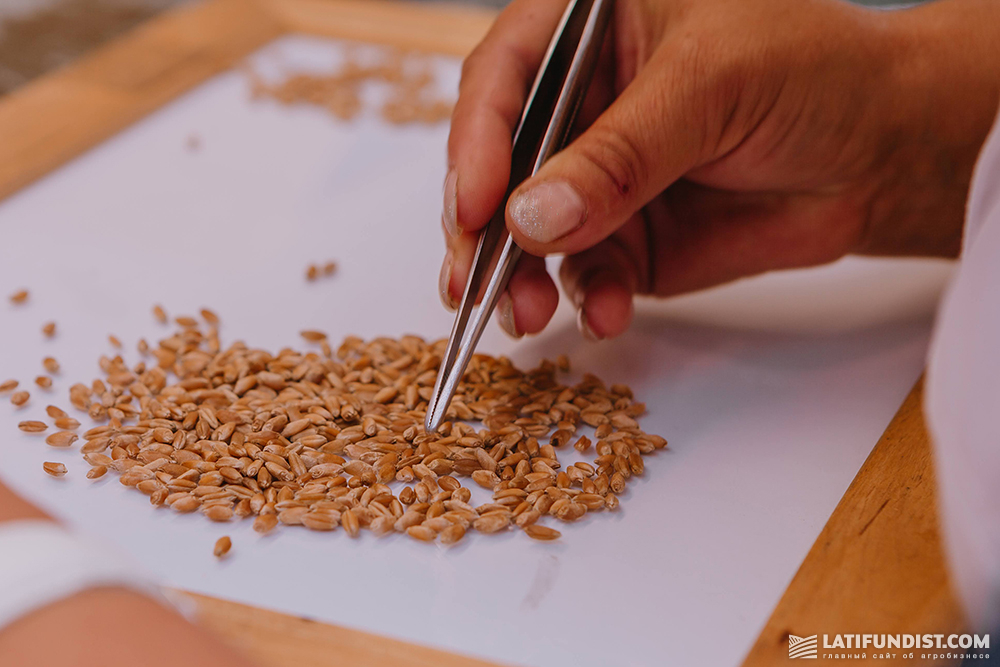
{"left": 0, "top": 0, "right": 495, "bottom": 206}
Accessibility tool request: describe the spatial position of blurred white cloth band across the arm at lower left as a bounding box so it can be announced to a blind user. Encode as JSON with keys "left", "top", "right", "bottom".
{"left": 0, "top": 520, "right": 162, "bottom": 629}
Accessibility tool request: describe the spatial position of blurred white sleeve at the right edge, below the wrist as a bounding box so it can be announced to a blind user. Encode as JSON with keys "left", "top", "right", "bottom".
{"left": 924, "top": 109, "right": 1000, "bottom": 630}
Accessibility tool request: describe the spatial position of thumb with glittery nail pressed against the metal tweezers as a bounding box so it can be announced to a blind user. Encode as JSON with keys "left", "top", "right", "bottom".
{"left": 507, "top": 48, "right": 707, "bottom": 256}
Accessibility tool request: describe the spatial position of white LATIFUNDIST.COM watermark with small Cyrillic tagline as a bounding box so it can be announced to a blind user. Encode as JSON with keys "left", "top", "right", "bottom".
{"left": 788, "top": 634, "right": 990, "bottom": 663}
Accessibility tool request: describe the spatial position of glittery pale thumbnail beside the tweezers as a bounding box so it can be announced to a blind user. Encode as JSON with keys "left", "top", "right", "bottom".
{"left": 510, "top": 181, "right": 587, "bottom": 243}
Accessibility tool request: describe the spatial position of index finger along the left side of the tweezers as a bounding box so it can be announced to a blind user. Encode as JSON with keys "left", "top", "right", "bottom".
{"left": 444, "top": 0, "right": 567, "bottom": 231}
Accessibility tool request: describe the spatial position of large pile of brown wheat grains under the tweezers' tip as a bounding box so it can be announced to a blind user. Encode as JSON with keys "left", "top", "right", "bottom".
{"left": 5, "top": 307, "right": 666, "bottom": 544}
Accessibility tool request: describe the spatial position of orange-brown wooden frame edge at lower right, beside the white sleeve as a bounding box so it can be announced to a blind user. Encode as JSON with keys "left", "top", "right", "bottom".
{"left": 743, "top": 379, "right": 965, "bottom": 667}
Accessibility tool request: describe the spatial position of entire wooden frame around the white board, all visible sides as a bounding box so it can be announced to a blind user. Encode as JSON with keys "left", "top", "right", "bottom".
{"left": 0, "top": 0, "right": 964, "bottom": 667}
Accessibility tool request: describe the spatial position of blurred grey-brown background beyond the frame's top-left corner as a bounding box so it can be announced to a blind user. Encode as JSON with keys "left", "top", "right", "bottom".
{"left": 0, "top": 0, "right": 908, "bottom": 95}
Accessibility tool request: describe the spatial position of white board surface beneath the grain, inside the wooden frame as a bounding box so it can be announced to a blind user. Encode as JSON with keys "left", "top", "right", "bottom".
{"left": 0, "top": 38, "right": 949, "bottom": 667}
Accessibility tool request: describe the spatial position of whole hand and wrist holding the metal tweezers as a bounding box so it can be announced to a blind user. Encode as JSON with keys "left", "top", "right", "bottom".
{"left": 441, "top": 0, "right": 1000, "bottom": 338}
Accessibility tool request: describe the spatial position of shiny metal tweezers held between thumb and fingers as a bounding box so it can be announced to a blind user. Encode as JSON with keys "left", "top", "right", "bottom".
{"left": 424, "top": 0, "right": 613, "bottom": 433}
